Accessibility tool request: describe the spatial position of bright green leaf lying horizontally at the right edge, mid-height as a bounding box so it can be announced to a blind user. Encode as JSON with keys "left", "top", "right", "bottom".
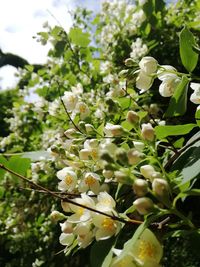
{"left": 155, "top": 123, "right": 197, "bottom": 139}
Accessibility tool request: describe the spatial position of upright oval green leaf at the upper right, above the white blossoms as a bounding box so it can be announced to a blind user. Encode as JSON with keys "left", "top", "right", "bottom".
{"left": 179, "top": 27, "right": 198, "bottom": 72}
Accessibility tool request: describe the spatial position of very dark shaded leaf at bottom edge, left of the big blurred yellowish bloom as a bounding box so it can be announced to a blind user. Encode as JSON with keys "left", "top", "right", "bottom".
{"left": 90, "top": 237, "right": 115, "bottom": 267}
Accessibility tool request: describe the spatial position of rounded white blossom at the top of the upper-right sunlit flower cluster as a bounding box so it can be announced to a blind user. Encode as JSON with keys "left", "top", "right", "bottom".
{"left": 139, "top": 57, "right": 158, "bottom": 75}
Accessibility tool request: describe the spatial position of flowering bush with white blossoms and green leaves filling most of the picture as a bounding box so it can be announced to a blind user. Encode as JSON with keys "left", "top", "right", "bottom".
{"left": 0, "top": 0, "right": 200, "bottom": 267}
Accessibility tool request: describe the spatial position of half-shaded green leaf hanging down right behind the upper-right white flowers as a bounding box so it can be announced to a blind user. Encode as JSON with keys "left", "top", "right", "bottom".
{"left": 165, "top": 76, "right": 189, "bottom": 117}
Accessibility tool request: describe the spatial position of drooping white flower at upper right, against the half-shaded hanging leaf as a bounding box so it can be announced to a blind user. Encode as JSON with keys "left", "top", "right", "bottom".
{"left": 159, "top": 73, "right": 181, "bottom": 97}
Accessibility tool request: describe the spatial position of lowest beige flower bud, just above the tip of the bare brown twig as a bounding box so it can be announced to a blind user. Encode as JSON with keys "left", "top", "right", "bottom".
{"left": 133, "top": 197, "right": 154, "bottom": 215}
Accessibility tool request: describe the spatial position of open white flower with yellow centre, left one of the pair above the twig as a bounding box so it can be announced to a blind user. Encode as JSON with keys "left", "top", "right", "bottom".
{"left": 56, "top": 167, "right": 77, "bottom": 191}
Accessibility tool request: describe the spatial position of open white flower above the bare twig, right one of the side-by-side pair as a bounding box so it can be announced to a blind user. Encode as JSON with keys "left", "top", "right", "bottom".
{"left": 79, "top": 172, "right": 100, "bottom": 194}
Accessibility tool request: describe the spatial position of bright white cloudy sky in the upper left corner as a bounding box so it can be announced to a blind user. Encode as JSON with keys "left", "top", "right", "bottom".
{"left": 0, "top": 0, "right": 101, "bottom": 89}
